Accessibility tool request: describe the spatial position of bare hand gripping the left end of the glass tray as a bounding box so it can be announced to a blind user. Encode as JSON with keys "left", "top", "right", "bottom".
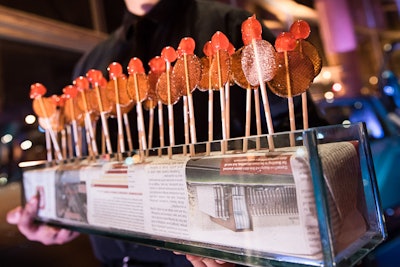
{"left": 7, "top": 196, "right": 79, "bottom": 245}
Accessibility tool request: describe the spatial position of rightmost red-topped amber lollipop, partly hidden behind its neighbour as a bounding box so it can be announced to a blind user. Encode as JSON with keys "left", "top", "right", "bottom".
{"left": 290, "top": 20, "right": 322, "bottom": 129}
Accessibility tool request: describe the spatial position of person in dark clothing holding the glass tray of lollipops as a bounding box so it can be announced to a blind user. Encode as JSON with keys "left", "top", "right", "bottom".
{"left": 7, "top": 0, "right": 324, "bottom": 267}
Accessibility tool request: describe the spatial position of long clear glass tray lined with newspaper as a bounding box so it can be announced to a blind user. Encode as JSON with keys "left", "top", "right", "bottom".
{"left": 21, "top": 123, "right": 386, "bottom": 266}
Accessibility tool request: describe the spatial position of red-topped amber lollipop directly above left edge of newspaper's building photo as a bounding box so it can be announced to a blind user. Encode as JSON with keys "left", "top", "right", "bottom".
{"left": 172, "top": 37, "right": 201, "bottom": 155}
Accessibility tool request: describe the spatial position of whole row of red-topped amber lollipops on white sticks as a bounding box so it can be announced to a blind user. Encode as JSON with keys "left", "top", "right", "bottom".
{"left": 30, "top": 16, "right": 322, "bottom": 163}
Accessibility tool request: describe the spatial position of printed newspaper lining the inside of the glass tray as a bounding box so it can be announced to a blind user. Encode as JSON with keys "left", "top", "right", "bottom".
{"left": 24, "top": 142, "right": 368, "bottom": 260}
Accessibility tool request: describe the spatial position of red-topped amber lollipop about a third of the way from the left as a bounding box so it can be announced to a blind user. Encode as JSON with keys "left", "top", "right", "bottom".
{"left": 127, "top": 57, "right": 149, "bottom": 157}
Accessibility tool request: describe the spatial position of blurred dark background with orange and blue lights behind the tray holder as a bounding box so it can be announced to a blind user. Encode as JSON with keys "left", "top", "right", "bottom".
{"left": 0, "top": 0, "right": 400, "bottom": 267}
